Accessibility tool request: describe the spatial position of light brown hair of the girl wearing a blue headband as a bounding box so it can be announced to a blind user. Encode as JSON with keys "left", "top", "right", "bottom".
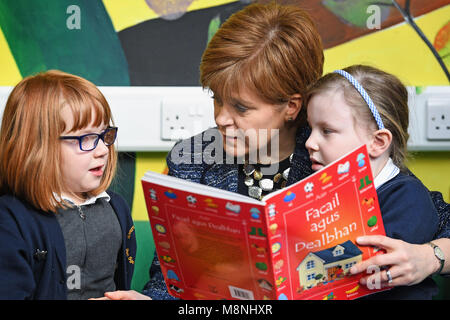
{"left": 306, "top": 65, "right": 409, "bottom": 170}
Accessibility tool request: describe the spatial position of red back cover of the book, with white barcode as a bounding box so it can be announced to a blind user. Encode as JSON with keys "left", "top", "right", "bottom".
{"left": 142, "top": 173, "right": 268, "bottom": 299}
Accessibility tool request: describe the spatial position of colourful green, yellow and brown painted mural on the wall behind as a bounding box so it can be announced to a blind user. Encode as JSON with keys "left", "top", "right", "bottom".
{"left": 0, "top": 0, "right": 450, "bottom": 289}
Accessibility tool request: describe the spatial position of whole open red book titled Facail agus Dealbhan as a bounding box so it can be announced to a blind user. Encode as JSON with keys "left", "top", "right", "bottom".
{"left": 142, "top": 146, "right": 385, "bottom": 300}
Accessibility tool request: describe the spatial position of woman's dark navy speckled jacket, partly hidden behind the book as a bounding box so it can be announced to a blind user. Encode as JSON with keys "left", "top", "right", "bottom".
{"left": 143, "top": 126, "right": 450, "bottom": 299}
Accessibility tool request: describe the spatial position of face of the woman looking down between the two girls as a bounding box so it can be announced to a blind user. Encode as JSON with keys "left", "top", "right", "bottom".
{"left": 214, "top": 89, "right": 286, "bottom": 158}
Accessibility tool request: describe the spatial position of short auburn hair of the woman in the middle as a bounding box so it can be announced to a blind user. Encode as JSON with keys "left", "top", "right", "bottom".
{"left": 200, "top": 3, "right": 324, "bottom": 122}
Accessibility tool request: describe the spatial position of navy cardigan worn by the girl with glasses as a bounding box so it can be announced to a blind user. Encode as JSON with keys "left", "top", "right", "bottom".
{"left": 0, "top": 191, "right": 136, "bottom": 300}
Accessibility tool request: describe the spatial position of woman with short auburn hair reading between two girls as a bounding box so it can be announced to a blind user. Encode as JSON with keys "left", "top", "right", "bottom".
{"left": 103, "top": 4, "right": 450, "bottom": 299}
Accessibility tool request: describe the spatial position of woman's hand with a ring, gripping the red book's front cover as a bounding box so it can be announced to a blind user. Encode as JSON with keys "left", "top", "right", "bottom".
{"left": 350, "top": 236, "right": 439, "bottom": 287}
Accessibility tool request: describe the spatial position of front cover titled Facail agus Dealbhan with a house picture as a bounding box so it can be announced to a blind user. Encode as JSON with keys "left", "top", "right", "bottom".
{"left": 264, "top": 146, "right": 385, "bottom": 300}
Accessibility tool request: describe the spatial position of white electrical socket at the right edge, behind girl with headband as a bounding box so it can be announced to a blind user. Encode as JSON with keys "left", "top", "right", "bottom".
{"left": 427, "top": 98, "right": 450, "bottom": 140}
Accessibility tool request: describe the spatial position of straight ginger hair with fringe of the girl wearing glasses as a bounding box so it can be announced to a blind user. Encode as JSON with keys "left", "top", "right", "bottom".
{"left": 0, "top": 70, "right": 117, "bottom": 212}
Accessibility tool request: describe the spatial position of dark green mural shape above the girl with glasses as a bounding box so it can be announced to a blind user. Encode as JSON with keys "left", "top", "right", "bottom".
{"left": 0, "top": 0, "right": 130, "bottom": 86}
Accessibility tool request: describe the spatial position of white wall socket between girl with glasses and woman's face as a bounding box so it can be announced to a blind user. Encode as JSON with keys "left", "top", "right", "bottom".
{"left": 161, "top": 97, "right": 214, "bottom": 141}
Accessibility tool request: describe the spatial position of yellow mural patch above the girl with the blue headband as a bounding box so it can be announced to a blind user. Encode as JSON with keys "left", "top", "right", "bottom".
{"left": 324, "top": 5, "right": 450, "bottom": 86}
